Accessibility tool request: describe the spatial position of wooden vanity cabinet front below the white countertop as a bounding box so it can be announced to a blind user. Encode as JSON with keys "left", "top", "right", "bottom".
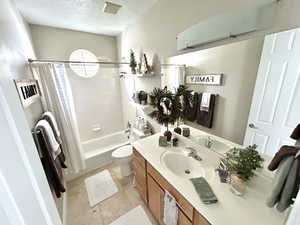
{"left": 133, "top": 149, "right": 211, "bottom": 225}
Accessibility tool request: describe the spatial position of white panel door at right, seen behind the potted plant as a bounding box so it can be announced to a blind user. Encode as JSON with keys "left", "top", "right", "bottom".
{"left": 244, "top": 29, "right": 300, "bottom": 156}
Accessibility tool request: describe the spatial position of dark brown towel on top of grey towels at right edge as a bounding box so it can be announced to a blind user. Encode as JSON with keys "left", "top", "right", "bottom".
{"left": 268, "top": 145, "right": 300, "bottom": 171}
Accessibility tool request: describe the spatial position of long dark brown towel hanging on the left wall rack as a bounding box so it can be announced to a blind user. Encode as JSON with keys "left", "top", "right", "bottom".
{"left": 36, "top": 127, "right": 66, "bottom": 198}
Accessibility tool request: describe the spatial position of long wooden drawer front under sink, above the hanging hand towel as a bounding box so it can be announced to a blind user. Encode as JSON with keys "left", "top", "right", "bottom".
{"left": 147, "top": 163, "right": 193, "bottom": 221}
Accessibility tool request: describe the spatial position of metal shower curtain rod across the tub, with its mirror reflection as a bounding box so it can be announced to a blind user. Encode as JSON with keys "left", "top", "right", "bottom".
{"left": 28, "top": 59, "right": 185, "bottom": 67}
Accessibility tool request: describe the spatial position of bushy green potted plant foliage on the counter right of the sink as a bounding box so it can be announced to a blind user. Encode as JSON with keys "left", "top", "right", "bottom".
{"left": 225, "top": 145, "right": 264, "bottom": 181}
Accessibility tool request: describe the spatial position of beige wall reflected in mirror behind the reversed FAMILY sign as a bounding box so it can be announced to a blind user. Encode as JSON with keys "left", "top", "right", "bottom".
{"left": 170, "top": 38, "right": 264, "bottom": 144}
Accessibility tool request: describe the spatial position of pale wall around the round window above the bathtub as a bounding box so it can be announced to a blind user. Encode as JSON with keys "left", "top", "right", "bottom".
{"left": 30, "top": 25, "right": 123, "bottom": 142}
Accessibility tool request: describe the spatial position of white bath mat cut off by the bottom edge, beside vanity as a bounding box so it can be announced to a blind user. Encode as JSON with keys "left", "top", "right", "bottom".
{"left": 109, "top": 206, "right": 152, "bottom": 225}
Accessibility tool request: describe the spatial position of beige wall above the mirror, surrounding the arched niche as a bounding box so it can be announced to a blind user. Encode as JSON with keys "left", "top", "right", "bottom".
{"left": 118, "top": 0, "right": 300, "bottom": 140}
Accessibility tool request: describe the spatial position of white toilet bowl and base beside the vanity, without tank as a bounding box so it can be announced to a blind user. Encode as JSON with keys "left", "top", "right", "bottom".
{"left": 112, "top": 145, "right": 132, "bottom": 177}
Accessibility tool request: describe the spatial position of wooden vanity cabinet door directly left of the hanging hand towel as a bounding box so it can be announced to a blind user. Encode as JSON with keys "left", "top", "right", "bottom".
{"left": 147, "top": 175, "right": 164, "bottom": 225}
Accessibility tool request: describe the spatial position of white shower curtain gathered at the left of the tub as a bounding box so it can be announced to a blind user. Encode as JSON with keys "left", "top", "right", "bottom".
{"left": 32, "top": 64, "right": 85, "bottom": 173}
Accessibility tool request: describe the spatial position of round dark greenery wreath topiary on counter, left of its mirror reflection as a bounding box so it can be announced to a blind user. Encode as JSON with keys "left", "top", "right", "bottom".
{"left": 149, "top": 87, "right": 181, "bottom": 128}
